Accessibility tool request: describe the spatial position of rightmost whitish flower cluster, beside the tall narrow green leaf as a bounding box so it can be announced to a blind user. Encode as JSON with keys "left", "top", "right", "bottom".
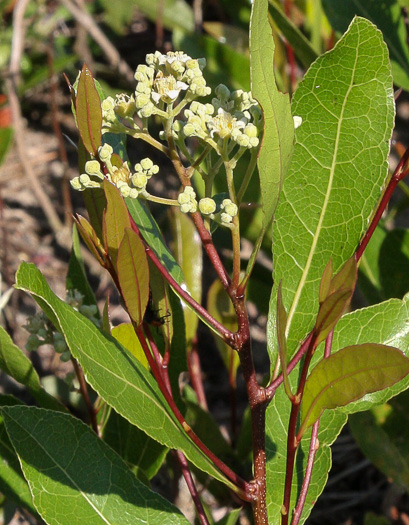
{"left": 177, "top": 84, "right": 262, "bottom": 149}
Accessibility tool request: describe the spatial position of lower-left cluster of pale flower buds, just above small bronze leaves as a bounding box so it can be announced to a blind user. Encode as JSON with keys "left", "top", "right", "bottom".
{"left": 71, "top": 144, "right": 159, "bottom": 199}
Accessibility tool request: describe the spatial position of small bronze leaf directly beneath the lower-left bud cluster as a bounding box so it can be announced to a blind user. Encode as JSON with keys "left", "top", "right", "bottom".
{"left": 103, "top": 180, "right": 131, "bottom": 265}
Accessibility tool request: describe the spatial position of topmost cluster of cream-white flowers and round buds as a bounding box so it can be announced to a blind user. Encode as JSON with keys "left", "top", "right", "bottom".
{"left": 135, "top": 51, "right": 211, "bottom": 118}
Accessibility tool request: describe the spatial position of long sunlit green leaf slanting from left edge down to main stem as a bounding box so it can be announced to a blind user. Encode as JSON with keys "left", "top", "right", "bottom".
{"left": 16, "top": 263, "right": 236, "bottom": 487}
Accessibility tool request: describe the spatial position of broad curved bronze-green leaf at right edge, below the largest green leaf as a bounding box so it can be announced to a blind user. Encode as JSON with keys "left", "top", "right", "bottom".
{"left": 300, "top": 343, "right": 409, "bottom": 434}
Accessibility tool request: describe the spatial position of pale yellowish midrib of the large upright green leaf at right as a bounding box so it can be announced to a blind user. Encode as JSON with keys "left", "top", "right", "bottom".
{"left": 286, "top": 33, "right": 359, "bottom": 337}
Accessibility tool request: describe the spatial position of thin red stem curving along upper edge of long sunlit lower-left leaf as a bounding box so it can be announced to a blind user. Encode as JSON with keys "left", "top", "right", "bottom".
{"left": 134, "top": 326, "right": 251, "bottom": 501}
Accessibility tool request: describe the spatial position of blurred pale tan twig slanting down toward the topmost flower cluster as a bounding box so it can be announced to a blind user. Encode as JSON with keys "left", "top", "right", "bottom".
{"left": 61, "top": 0, "right": 135, "bottom": 83}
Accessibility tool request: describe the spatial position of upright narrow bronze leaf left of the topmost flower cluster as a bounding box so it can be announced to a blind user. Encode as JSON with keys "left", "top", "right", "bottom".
{"left": 75, "top": 64, "right": 102, "bottom": 157}
